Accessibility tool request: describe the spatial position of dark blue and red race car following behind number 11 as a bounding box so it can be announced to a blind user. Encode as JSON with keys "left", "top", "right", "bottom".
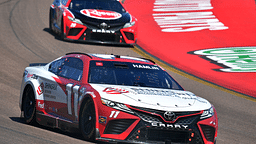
{"left": 49, "top": 0, "right": 138, "bottom": 45}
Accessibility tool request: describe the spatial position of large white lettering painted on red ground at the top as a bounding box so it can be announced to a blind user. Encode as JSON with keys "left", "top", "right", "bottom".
{"left": 153, "top": 0, "right": 228, "bottom": 32}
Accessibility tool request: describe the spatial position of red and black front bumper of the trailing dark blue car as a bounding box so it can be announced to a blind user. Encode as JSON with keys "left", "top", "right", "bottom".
{"left": 64, "top": 20, "right": 137, "bottom": 45}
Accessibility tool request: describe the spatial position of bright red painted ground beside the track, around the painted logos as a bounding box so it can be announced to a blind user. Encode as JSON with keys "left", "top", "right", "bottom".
{"left": 124, "top": 0, "right": 256, "bottom": 97}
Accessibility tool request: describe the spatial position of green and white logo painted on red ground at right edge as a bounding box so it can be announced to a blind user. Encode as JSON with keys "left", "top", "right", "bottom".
{"left": 189, "top": 47, "right": 256, "bottom": 72}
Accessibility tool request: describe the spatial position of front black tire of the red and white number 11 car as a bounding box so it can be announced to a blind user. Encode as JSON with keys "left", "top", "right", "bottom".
{"left": 79, "top": 99, "right": 96, "bottom": 140}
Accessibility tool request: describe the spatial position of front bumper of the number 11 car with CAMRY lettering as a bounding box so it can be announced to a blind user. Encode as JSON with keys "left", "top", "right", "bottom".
{"left": 97, "top": 107, "right": 217, "bottom": 144}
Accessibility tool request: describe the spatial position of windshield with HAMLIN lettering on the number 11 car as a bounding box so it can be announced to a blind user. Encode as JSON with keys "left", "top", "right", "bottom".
{"left": 88, "top": 61, "right": 183, "bottom": 90}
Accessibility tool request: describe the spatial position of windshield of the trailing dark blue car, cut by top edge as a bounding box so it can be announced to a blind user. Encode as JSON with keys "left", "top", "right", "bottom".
{"left": 69, "top": 0, "right": 125, "bottom": 13}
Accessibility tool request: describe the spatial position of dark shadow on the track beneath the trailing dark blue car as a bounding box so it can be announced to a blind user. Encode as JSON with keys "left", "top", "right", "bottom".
{"left": 43, "top": 28, "right": 134, "bottom": 48}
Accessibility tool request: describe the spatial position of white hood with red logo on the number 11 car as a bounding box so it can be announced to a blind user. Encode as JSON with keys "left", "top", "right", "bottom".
{"left": 91, "top": 84, "right": 211, "bottom": 111}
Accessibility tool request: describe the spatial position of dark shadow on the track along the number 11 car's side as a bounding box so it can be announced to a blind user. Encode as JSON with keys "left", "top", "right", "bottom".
{"left": 9, "top": 117, "right": 99, "bottom": 144}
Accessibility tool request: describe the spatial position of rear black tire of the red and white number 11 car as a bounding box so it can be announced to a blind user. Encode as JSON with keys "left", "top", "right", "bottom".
{"left": 22, "top": 87, "right": 36, "bottom": 124}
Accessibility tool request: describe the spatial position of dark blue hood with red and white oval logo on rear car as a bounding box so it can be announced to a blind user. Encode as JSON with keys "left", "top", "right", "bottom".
{"left": 70, "top": 9, "right": 131, "bottom": 24}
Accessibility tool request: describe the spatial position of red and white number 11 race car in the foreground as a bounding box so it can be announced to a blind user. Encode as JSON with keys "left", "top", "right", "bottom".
{"left": 19, "top": 52, "right": 218, "bottom": 144}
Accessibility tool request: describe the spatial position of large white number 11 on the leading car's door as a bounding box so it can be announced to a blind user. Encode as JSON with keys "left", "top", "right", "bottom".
{"left": 66, "top": 83, "right": 80, "bottom": 117}
